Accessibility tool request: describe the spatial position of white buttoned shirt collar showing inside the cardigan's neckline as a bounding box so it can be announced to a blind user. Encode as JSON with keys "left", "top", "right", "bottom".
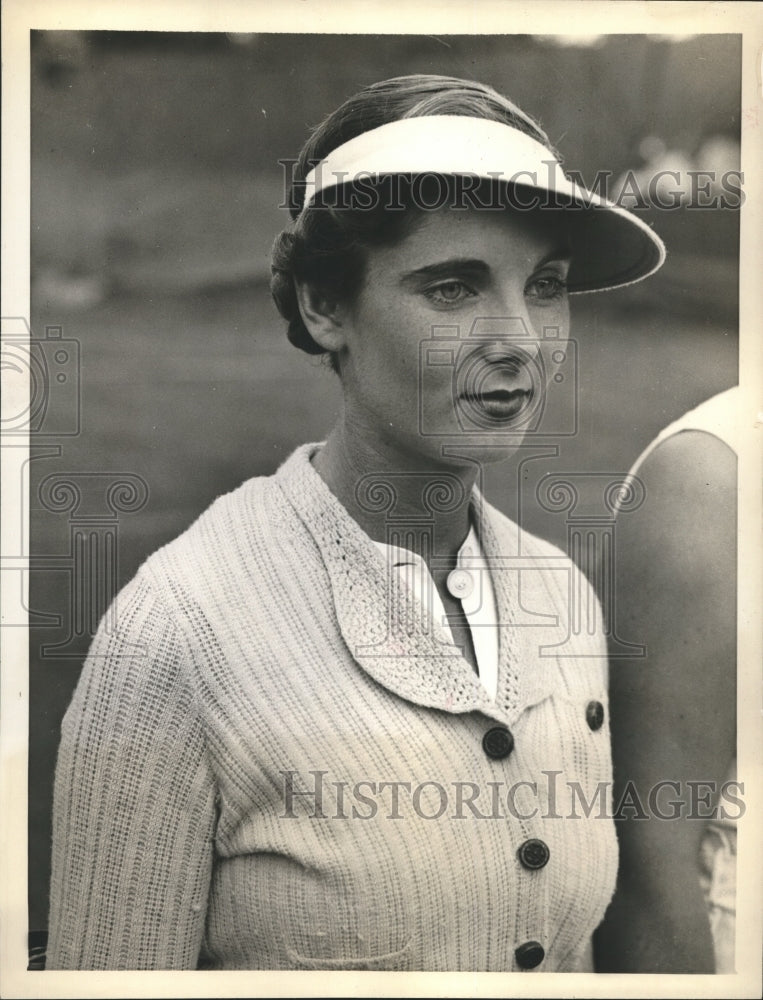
{"left": 374, "top": 527, "right": 498, "bottom": 699}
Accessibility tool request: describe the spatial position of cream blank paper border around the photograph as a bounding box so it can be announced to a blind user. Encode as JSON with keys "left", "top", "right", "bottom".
{"left": 0, "top": 0, "right": 763, "bottom": 998}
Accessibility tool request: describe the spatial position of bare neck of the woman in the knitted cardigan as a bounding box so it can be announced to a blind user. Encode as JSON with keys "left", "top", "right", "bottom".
{"left": 313, "top": 420, "right": 477, "bottom": 560}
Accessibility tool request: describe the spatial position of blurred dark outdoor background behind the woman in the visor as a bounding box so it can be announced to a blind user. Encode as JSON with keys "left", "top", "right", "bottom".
{"left": 29, "top": 31, "right": 741, "bottom": 940}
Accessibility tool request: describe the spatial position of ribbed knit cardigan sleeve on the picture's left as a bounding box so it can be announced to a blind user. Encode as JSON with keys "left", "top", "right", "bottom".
{"left": 47, "top": 575, "right": 216, "bottom": 969}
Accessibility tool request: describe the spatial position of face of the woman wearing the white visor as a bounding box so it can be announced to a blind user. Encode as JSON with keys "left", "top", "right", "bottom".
{"left": 340, "top": 208, "right": 572, "bottom": 461}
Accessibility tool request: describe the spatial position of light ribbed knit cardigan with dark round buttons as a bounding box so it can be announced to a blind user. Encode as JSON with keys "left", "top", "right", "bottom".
{"left": 48, "top": 445, "right": 617, "bottom": 971}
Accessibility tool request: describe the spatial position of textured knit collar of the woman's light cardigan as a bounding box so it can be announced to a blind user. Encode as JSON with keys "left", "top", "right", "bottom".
{"left": 275, "top": 443, "right": 558, "bottom": 725}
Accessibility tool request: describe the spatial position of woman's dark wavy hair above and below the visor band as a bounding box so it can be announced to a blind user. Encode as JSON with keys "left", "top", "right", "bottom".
{"left": 270, "top": 75, "right": 553, "bottom": 371}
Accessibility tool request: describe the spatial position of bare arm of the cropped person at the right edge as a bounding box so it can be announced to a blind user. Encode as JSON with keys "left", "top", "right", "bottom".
{"left": 596, "top": 431, "right": 736, "bottom": 973}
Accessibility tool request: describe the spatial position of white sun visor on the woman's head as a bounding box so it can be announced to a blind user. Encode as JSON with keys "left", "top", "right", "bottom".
{"left": 302, "top": 115, "right": 665, "bottom": 292}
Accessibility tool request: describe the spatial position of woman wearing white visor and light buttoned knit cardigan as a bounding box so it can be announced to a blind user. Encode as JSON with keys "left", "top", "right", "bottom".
{"left": 49, "top": 76, "right": 663, "bottom": 971}
